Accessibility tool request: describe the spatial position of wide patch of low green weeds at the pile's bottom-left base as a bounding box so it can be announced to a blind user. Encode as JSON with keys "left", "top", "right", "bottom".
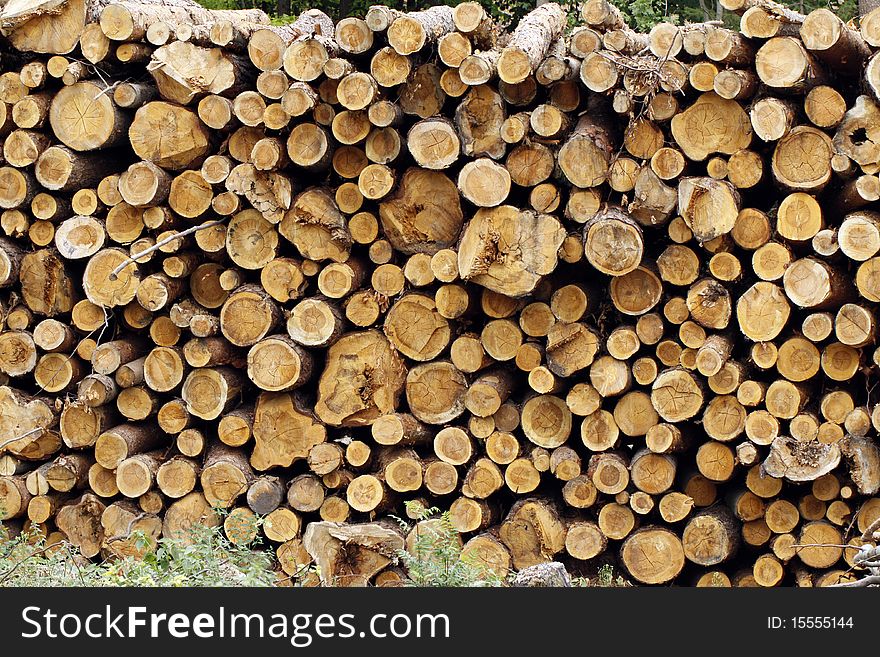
{"left": 0, "top": 523, "right": 276, "bottom": 587}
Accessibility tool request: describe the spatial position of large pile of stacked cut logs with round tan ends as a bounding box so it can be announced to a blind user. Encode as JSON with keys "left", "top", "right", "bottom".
{"left": 0, "top": 0, "right": 880, "bottom": 586}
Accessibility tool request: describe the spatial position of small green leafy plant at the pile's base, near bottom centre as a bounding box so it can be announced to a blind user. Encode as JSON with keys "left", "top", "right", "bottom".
{"left": 397, "top": 502, "right": 504, "bottom": 587}
